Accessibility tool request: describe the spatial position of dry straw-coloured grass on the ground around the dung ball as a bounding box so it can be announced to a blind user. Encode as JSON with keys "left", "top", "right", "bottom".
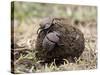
{"left": 11, "top": 19, "right": 97, "bottom": 73}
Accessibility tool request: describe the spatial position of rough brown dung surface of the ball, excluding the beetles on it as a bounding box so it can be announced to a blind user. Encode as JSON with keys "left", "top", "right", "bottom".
{"left": 36, "top": 18, "right": 85, "bottom": 62}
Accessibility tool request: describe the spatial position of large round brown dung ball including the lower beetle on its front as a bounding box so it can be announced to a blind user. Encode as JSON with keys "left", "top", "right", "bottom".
{"left": 36, "top": 18, "right": 85, "bottom": 62}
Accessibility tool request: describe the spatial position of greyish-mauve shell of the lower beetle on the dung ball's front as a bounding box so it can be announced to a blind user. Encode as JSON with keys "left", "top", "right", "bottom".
{"left": 42, "top": 31, "right": 60, "bottom": 51}
